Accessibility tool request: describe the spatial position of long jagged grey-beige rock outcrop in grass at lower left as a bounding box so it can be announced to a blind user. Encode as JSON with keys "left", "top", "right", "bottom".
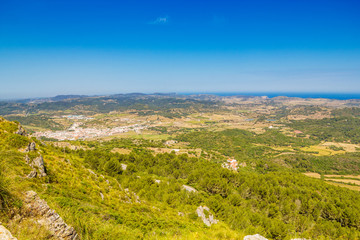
{"left": 25, "top": 191, "right": 80, "bottom": 240}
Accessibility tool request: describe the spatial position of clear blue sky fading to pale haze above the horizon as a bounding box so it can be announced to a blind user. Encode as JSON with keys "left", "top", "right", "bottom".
{"left": 0, "top": 0, "right": 360, "bottom": 99}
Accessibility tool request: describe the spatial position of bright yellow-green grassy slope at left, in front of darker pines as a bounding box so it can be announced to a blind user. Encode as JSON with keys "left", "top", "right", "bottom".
{"left": 0, "top": 116, "right": 245, "bottom": 239}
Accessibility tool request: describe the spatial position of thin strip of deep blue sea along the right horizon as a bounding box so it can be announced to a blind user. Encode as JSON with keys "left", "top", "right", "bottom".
{"left": 183, "top": 92, "right": 360, "bottom": 100}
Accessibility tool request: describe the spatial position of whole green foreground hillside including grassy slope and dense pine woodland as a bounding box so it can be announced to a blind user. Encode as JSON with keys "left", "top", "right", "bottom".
{"left": 0, "top": 119, "right": 360, "bottom": 239}
